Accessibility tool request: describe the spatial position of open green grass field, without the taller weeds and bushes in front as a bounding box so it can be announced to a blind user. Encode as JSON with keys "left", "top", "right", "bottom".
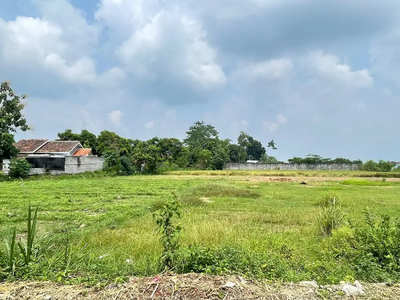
{"left": 0, "top": 172, "right": 400, "bottom": 283}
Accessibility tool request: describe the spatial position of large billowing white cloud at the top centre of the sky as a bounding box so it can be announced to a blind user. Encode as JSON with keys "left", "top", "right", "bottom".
{"left": 96, "top": 0, "right": 226, "bottom": 89}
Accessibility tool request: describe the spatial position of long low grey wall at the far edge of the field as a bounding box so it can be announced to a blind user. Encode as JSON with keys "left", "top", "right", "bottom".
{"left": 224, "top": 163, "right": 360, "bottom": 171}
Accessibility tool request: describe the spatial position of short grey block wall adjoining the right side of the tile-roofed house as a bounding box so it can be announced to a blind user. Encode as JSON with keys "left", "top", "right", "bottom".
{"left": 65, "top": 156, "right": 104, "bottom": 174}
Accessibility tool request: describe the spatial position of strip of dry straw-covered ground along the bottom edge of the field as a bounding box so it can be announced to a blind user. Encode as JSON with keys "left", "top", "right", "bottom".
{"left": 0, "top": 274, "right": 400, "bottom": 300}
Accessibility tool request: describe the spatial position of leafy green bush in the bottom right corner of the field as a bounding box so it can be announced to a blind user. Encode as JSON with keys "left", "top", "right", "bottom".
{"left": 328, "top": 213, "right": 400, "bottom": 282}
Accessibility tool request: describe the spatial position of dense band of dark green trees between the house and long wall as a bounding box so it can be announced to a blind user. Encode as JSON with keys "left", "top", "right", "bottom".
{"left": 58, "top": 121, "right": 278, "bottom": 175}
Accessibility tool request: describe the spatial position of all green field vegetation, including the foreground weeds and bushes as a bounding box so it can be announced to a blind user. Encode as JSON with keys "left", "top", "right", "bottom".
{"left": 0, "top": 173, "right": 400, "bottom": 284}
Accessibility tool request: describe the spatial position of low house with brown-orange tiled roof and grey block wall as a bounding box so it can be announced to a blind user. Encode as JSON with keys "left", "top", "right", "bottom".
{"left": 1, "top": 139, "right": 104, "bottom": 175}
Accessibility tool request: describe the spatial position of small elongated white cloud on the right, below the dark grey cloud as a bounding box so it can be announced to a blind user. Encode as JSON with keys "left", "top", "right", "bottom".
{"left": 311, "top": 51, "right": 374, "bottom": 88}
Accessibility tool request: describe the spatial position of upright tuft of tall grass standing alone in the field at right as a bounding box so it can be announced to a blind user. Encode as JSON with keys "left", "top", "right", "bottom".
{"left": 317, "top": 196, "right": 344, "bottom": 237}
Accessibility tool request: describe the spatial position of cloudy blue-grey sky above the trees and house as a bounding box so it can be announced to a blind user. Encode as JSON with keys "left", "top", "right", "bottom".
{"left": 0, "top": 0, "right": 400, "bottom": 161}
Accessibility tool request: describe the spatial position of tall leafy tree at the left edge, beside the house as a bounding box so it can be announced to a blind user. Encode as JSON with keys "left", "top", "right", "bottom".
{"left": 0, "top": 82, "right": 30, "bottom": 161}
